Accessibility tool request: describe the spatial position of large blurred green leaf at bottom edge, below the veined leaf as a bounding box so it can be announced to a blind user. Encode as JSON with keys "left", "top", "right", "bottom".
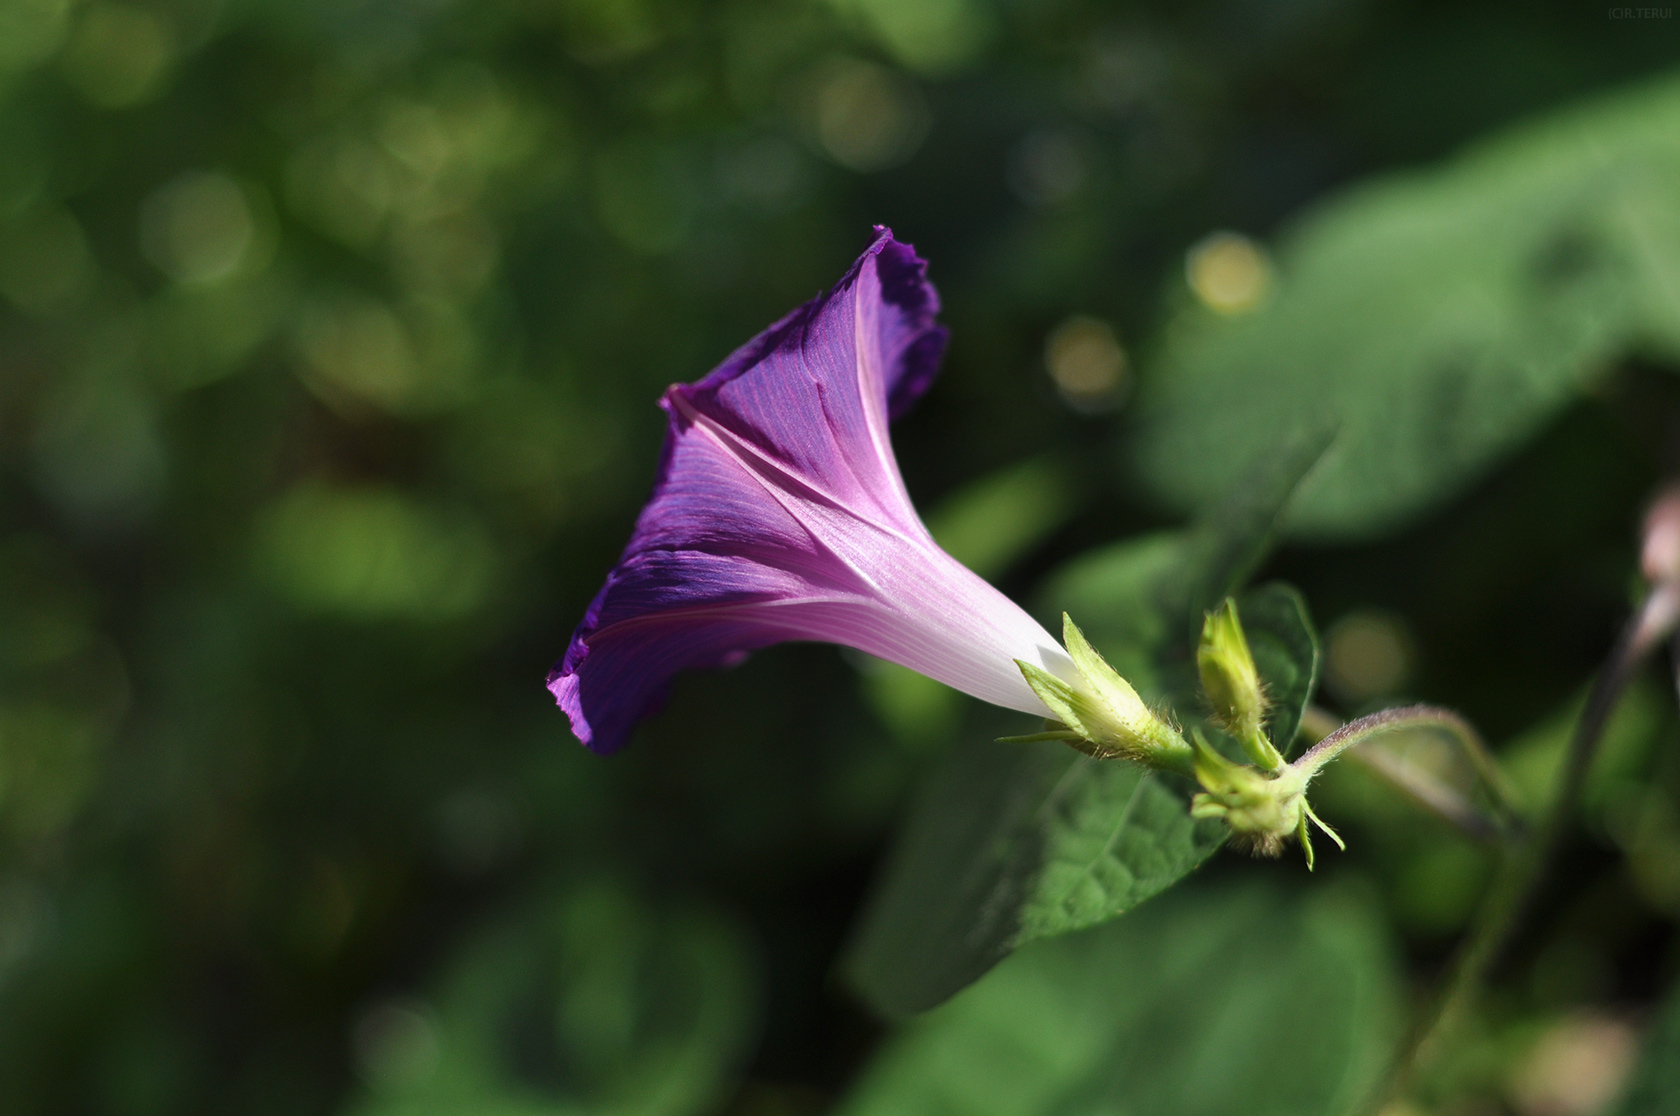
{"left": 838, "top": 879, "right": 1399, "bottom": 1116}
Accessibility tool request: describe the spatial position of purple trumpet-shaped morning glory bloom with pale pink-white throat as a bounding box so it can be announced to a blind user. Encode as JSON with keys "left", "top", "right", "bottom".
{"left": 548, "top": 227, "right": 1077, "bottom": 753}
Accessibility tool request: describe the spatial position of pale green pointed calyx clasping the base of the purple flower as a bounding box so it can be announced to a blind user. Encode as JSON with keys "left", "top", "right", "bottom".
{"left": 1016, "top": 613, "right": 1193, "bottom": 775}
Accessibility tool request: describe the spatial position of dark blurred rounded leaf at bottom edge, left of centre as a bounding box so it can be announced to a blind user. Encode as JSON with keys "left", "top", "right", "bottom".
{"left": 354, "top": 884, "right": 758, "bottom": 1116}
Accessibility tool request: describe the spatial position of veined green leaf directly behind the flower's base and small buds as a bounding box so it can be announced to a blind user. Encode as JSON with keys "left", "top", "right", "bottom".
{"left": 843, "top": 434, "right": 1326, "bottom": 1015}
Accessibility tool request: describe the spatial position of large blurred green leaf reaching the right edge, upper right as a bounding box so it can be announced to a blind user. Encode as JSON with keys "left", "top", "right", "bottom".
{"left": 1132, "top": 69, "right": 1680, "bottom": 538}
